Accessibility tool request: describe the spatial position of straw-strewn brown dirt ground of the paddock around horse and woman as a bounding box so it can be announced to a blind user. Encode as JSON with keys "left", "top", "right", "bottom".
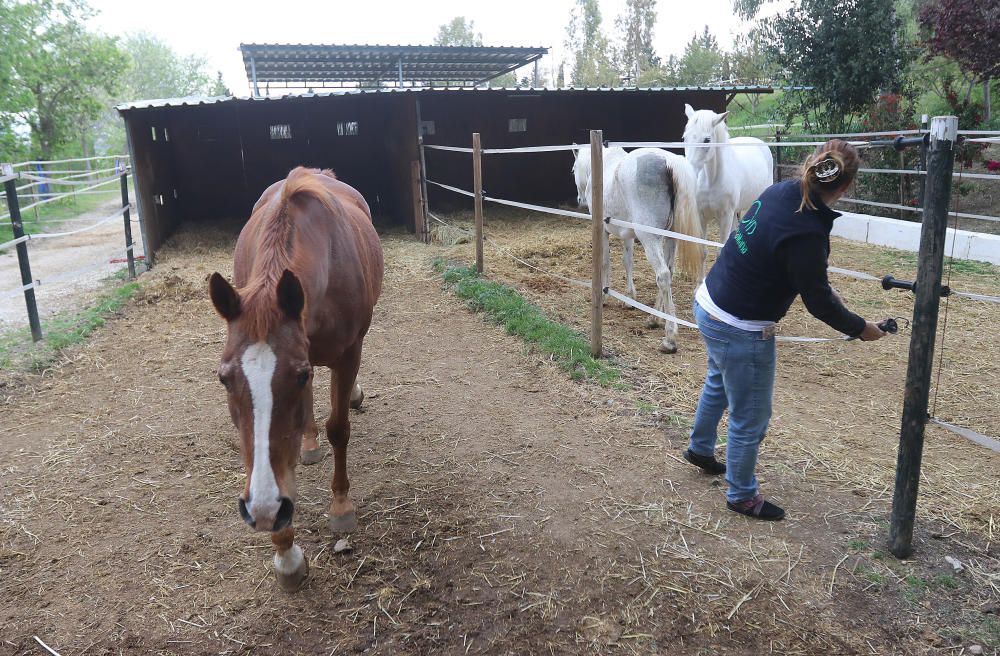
{"left": 0, "top": 219, "right": 1000, "bottom": 656}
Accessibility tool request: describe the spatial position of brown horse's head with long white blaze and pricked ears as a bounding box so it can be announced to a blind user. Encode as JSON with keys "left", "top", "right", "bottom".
{"left": 209, "top": 270, "right": 312, "bottom": 531}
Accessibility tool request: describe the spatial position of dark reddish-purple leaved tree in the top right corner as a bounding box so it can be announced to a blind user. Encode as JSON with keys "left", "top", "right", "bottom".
{"left": 920, "top": 0, "right": 1000, "bottom": 121}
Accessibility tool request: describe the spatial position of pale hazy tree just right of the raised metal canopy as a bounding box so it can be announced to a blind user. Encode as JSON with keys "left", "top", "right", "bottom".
{"left": 566, "top": 0, "right": 620, "bottom": 86}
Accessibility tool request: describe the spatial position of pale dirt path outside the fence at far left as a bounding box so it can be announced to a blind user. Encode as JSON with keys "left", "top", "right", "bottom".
{"left": 0, "top": 196, "right": 142, "bottom": 332}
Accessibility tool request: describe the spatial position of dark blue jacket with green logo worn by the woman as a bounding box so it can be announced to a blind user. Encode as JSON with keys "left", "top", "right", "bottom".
{"left": 705, "top": 180, "right": 865, "bottom": 336}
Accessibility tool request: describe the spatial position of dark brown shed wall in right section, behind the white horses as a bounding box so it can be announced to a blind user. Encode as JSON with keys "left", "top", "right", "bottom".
{"left": 420, "top": 91, "right": 726, "bottom": 209}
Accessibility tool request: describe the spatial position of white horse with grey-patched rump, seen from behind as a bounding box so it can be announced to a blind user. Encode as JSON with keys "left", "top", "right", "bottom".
{"left": 574, "top": 147, "right": 704, "bottom": 353}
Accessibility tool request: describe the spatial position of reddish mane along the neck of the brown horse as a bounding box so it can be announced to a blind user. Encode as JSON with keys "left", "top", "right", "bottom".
{"left": 240, "top": 166, "right": 337, "bottom": 341}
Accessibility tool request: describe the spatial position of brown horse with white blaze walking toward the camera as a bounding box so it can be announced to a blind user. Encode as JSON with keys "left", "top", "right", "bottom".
{"left": 209, "top": 167, "right": 383, "bottom": 591}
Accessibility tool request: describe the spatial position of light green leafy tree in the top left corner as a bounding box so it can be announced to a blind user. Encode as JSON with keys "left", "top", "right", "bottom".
{"left": 0, "top": 0, "right": 128, "bottom": 159}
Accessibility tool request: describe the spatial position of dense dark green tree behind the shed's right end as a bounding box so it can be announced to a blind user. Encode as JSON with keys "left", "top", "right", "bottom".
{"left": 763, "top": 0, "right": 906, "bottom": 131}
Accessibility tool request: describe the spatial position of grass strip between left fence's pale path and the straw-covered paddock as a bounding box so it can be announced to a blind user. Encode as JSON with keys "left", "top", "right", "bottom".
{"left": 0, "top": 273, "right": 139, "bottom": 371}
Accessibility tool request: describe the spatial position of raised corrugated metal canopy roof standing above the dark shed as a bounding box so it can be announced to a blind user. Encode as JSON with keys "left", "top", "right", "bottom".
{"left": 240, "top": 43, "right": 548, "bottom": 88}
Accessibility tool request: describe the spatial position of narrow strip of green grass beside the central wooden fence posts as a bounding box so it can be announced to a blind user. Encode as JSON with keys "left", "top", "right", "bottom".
{"left": 434, "top": 258, "right": 624, "bottom": 388}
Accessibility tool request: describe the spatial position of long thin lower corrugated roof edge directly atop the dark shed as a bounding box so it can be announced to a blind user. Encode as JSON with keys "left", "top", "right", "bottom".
{"left": 115, "top": 85, "right": 774, "bottom": 112}
